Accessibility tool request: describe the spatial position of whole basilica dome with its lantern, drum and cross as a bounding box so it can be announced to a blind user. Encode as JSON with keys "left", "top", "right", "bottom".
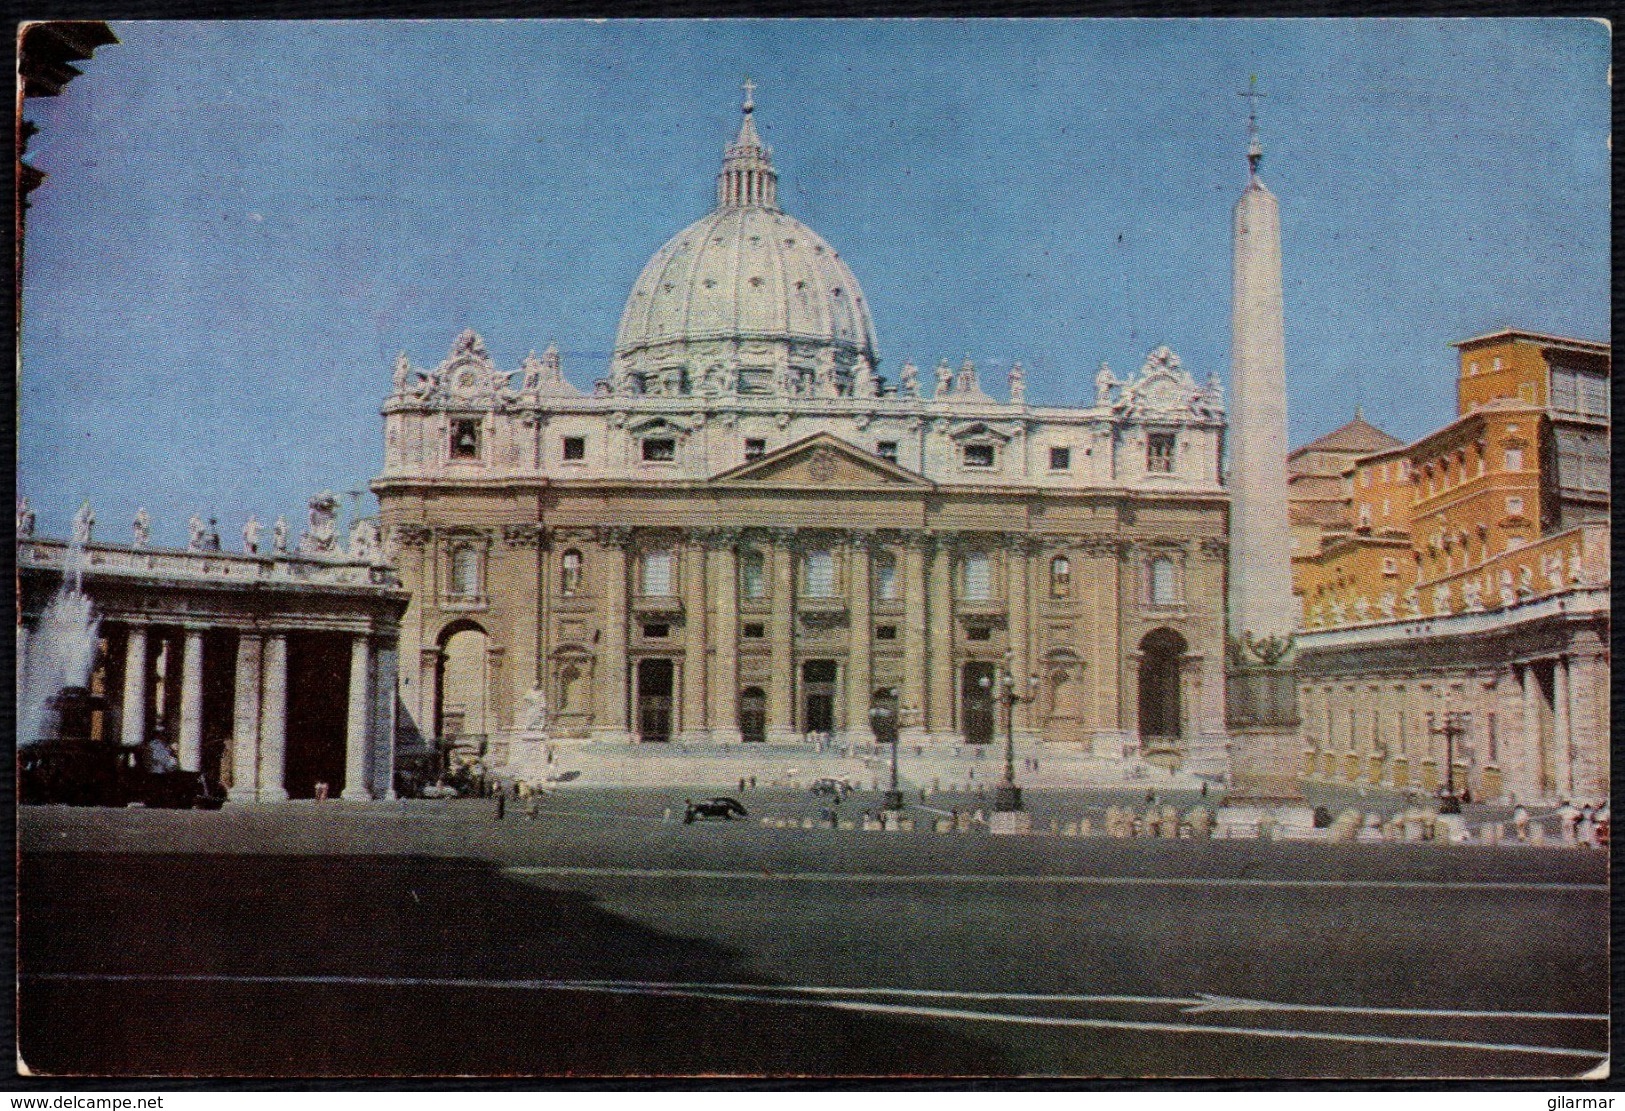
{"left": 613, "top": 88, "right": 876, "bottom": 395}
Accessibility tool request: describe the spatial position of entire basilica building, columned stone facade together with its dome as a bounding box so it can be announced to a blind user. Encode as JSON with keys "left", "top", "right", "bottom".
{"left": 372, "top": 90, "right": 1229, "bottom": 755}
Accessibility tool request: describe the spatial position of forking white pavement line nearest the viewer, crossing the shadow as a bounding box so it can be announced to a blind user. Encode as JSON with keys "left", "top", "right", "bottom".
{"left": 21, "top": 973, "right": 1607, "bottom": 1059}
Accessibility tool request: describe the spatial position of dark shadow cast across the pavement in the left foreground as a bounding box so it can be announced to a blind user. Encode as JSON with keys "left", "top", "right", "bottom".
{"left": 18, "top": 853, "right": 1012, "bottom": 1075}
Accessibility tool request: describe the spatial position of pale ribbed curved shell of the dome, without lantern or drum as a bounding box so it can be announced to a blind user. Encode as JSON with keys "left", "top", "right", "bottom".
{"left": 616, "top": 205, "right": 874, "bottom": 362}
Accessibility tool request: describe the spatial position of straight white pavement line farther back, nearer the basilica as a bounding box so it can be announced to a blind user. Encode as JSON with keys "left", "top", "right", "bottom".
{"left": 502, "top": 864, "right": 1609, "bottom": 892}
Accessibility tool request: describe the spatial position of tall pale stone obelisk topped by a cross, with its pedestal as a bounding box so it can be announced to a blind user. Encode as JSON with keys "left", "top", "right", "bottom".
{"left": 1225, "top": 86, "right": 1303, "bottom": 804}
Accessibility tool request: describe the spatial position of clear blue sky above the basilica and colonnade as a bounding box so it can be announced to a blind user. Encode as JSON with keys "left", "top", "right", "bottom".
{"left": 18, "top": 12, "right": 1609, "bottom": 543}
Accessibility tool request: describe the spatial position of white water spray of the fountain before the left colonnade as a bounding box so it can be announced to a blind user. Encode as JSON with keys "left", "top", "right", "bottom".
{"left": 16, "top": 536, "right": 101, "bottom": 746}
